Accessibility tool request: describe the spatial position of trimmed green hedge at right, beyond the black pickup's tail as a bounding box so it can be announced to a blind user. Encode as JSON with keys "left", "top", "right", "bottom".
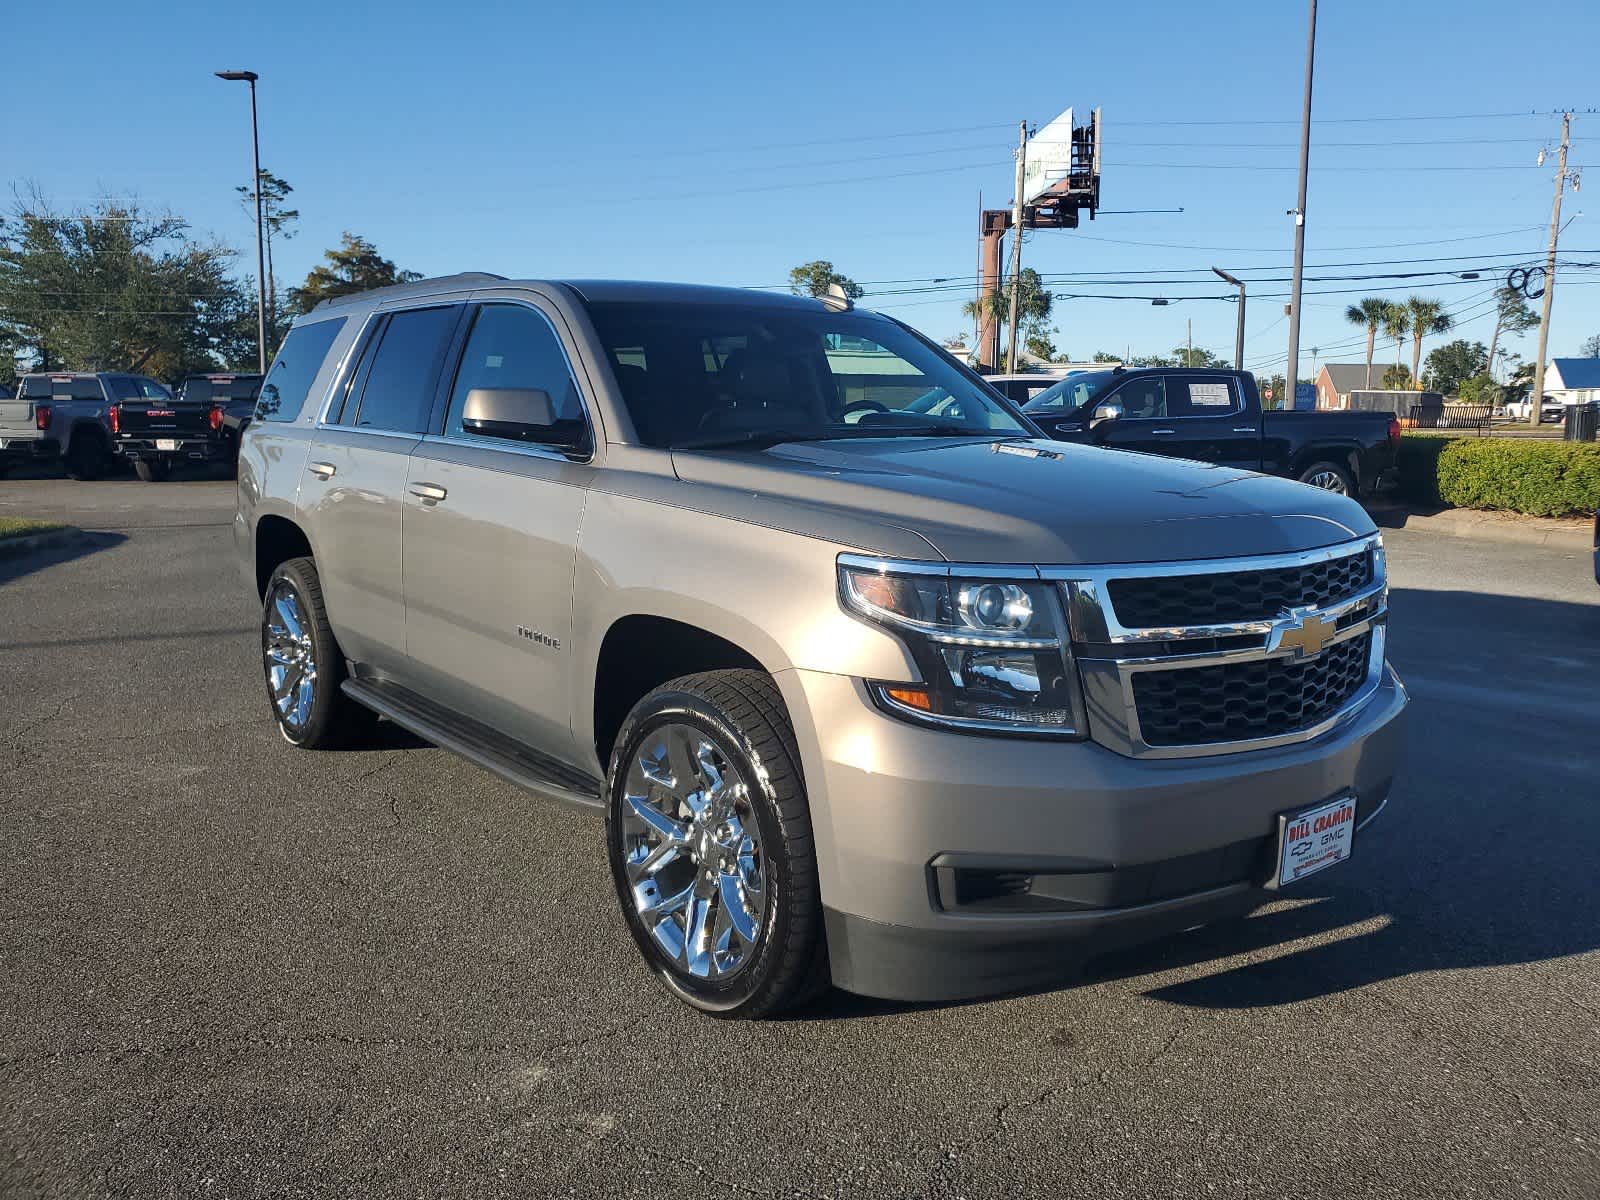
{"left": 1400, "top": 434, "right": 1600, "bottom": 517}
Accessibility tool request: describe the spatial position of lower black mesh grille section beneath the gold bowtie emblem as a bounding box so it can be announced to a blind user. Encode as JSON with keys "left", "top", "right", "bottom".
{"left": 1133, "top": 634, "right": 1373, "bottom": 746}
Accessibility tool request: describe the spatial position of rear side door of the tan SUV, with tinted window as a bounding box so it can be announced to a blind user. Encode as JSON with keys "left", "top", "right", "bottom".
{"left": 301, "top": 304, "right": 462, "bottom": 675}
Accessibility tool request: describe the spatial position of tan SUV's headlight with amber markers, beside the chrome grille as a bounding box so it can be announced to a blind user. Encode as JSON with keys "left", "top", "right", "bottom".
{"left": 838, "top": 555, "right": 1085, "bottom": 738}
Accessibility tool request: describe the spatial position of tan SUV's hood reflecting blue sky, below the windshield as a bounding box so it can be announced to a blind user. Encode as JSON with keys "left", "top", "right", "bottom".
{"left": 674, "top": 438, "right": 1374, "bottom": 565}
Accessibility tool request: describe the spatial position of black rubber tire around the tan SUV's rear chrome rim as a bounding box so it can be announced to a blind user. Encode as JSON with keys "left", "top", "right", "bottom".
{"left": 261, "top": 558, "right": 378, "bottom": 750}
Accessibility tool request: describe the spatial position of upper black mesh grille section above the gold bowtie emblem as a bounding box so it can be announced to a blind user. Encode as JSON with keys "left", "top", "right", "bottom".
{"left": 1107, "top": 549, "right": 1373, "bottom": 629}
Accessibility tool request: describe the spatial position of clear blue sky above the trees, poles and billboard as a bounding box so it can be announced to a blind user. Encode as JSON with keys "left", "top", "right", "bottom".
{"left": 9, "top": 0, "right": 1600, "bottom": 374}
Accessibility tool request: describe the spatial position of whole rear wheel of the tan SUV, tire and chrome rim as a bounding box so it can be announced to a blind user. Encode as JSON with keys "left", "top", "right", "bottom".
{"left": 261, "top": 558, "right": 378, "bottom": 750}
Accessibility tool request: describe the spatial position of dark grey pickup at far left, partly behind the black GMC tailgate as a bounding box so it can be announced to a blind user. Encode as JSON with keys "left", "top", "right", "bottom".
{"left": 0, "top": 371, "right": 173, "bottom": 480}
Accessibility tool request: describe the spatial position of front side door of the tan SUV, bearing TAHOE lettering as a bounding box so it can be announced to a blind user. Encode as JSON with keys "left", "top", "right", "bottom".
{"left": 403, "top": 299, "right": 595, "bottom": 762}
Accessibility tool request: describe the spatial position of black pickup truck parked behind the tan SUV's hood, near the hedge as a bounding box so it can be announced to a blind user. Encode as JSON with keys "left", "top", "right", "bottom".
{"left": 1022, "top": 366, "right": 1400, "bottom": 496}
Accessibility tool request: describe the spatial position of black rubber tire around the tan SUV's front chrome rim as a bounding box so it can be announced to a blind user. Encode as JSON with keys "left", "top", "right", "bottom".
{"left": 606, "top": 670, "right": 829, "bottom": 1019}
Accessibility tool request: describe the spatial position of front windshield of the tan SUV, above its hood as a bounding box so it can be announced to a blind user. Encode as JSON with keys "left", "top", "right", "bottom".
{"left": 589, "top": 301, "right": 1035, "bottom": 448}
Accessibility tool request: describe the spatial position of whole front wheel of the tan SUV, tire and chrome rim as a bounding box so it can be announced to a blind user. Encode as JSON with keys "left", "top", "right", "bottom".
{"left": 606, "top": 670, "right": 829, "bottom": 1018}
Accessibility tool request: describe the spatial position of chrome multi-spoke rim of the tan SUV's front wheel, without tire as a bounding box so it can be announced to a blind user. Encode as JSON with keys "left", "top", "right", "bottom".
{"left": 621, "top": 723, "right": 766, "bottom": 979}
